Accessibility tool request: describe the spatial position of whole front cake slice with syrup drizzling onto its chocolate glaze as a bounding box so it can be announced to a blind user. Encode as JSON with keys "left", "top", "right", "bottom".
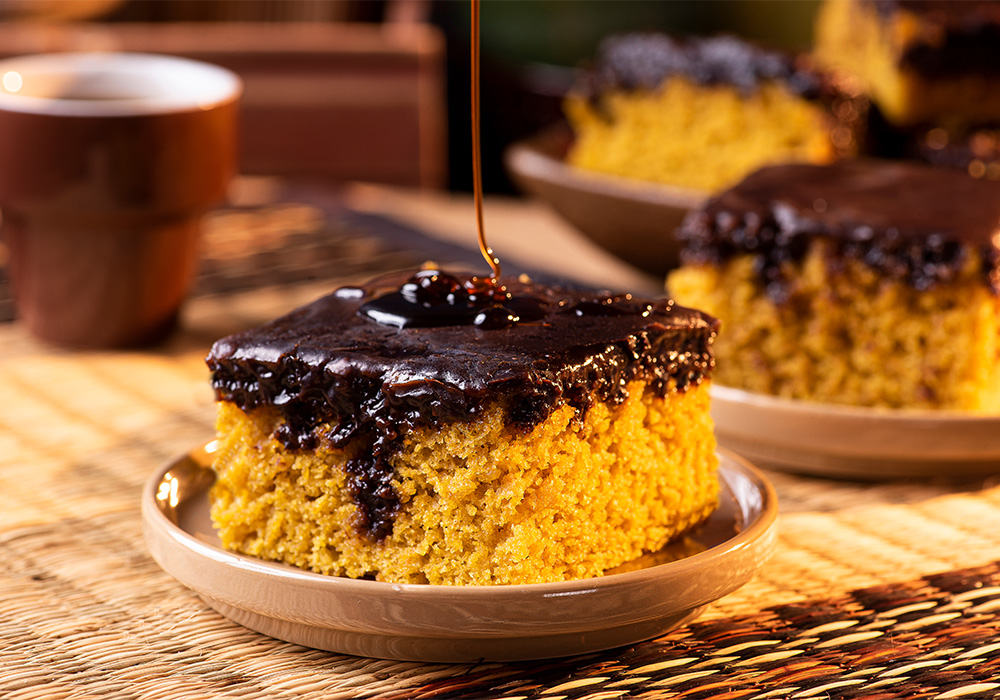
{"left": 208, "top": 271, "right": 718, "bottom": 584}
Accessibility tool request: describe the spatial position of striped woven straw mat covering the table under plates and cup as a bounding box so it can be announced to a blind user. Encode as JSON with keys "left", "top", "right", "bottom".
{"left": 0, "top": 189, "right": 1000, "bottom": 700}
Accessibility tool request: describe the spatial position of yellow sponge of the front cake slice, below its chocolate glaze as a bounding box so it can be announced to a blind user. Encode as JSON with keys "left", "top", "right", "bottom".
{"left": 212, "top": 382, "right": 718, "bottom": 585}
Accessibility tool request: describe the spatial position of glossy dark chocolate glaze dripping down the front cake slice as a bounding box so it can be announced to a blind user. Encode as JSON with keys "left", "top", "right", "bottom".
{"left": 207, "top": 272, "right": 717, "bottom": 539}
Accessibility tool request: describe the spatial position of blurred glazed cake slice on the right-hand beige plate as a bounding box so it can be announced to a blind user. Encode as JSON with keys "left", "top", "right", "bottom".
{"left": 668, "top": 161, "right": 1000, "bottom": 413}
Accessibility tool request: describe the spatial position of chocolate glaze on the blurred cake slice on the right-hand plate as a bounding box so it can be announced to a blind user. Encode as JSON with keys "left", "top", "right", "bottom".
{"left": 678, "top": 160, "right": 1000, "bottom": 302}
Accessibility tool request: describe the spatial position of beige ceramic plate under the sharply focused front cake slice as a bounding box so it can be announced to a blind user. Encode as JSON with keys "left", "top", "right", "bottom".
{"left": 142, "top": 446, "right": 778, "bottom": 662}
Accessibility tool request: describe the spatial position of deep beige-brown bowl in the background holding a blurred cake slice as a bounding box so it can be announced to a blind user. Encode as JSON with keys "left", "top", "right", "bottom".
{"left": 504, "top": 125, "right": 706, "bottom": 276}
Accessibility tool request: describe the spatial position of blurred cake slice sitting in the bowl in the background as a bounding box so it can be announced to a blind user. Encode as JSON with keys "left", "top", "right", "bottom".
{"left": 565, "top": 34, "right": 867, "bottom": 192}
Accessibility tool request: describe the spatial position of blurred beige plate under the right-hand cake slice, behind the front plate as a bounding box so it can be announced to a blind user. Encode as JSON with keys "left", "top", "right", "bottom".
{"left": 712, "top": 385, "right": 1000, "bottom": 479}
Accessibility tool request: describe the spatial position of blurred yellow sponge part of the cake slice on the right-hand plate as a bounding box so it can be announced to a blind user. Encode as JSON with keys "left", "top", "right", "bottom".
{"left": 669, "top": 246, "right": 1000, "bottom": 414}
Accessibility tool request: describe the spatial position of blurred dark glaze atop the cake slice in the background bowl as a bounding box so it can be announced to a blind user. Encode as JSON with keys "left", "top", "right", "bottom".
{"left": 580, "top": 33, "right": 824, "bottom": 98}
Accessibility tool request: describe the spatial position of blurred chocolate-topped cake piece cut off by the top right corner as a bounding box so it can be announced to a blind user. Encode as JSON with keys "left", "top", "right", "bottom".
{"left": 815, "top": 0, "right": 1000, "bottom": 126}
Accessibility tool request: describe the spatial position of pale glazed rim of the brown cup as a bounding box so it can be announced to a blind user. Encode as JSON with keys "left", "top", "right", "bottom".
{"left": 0, "top": 52, "right": 243, "bottom": 117}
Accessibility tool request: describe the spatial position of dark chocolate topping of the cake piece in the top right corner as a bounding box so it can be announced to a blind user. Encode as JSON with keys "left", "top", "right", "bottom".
{"left": 868, "top": 0, "right": 1000, "bottom": 78}
